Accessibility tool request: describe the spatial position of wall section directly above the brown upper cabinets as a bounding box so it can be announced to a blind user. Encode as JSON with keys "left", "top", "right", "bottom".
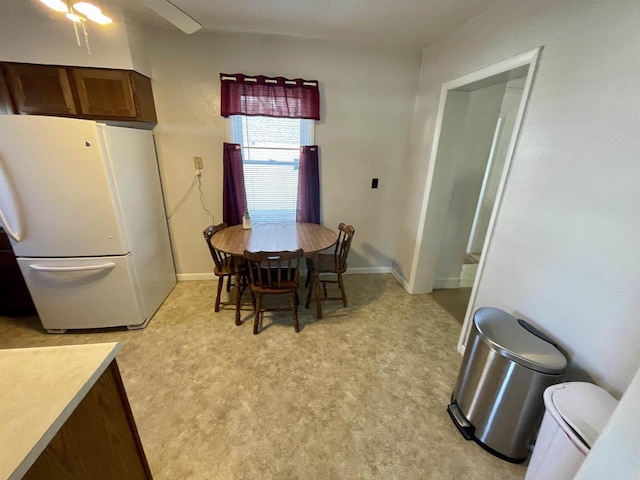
{"left": 0, "top": 0, "right": 151, "bottom": 76}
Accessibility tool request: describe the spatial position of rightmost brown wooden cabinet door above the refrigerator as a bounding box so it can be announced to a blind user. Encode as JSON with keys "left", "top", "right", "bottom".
{"left": 71, "top": 68, "right": 138, "bottom": 119}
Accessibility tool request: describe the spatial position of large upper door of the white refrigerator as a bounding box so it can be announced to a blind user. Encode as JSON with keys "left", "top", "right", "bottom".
{"left": 0, "top": 115, "right": 130, "bottom": 257}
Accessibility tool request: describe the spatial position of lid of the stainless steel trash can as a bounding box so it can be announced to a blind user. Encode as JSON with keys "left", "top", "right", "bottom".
{"left": 473, "top": 307, "right": 567, "bottom": 375}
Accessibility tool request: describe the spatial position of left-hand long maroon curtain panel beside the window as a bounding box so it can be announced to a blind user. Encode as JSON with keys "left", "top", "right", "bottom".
{"left": 222, "top": 143, "right": 247, "bottom": 226}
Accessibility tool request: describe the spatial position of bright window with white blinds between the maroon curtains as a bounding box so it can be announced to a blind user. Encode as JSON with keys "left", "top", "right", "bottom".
{"left": 229, "top": 115, "right": 314, "bottom": 222}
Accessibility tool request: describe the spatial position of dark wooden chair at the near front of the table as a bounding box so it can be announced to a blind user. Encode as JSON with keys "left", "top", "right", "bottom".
{"left": 244, "top": 249, "right": 303, "bottom": 335}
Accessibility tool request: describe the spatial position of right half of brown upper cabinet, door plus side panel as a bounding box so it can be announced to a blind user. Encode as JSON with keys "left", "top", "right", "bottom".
{"left": 69, "top": 68, "right": 156, "bottom": 123}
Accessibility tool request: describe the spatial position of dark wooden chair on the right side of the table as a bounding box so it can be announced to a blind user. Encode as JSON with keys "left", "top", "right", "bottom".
{"left": 304, "top": 223, "right": 356, "bottom": 318}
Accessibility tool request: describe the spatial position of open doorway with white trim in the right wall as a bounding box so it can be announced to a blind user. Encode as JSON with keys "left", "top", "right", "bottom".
{"left": 409, "top": 49, "right": 540, "bottom": 353}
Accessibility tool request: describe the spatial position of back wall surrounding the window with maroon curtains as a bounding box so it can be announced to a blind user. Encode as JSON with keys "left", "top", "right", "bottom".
{"left": 148, "top": 31, "right": 420, "bottom": 279}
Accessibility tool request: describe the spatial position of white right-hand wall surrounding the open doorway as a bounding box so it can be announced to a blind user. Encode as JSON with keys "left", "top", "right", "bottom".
{"left": 396, "top": 0, "right": 640, "bottom": 395}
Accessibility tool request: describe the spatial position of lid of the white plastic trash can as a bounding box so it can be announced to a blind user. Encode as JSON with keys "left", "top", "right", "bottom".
{"left": 544, "top": 382, "right": 618, "bottom": 448}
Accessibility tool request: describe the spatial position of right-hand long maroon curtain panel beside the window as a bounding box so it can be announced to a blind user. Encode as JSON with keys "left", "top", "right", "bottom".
{"left": 296, "top": 145, "right": 320, "bottom": 224}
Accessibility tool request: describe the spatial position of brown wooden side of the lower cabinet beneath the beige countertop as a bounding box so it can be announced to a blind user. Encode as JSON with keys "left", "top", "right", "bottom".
{"left": 23, "top": 360, "right": 152, "bottom": 480}
